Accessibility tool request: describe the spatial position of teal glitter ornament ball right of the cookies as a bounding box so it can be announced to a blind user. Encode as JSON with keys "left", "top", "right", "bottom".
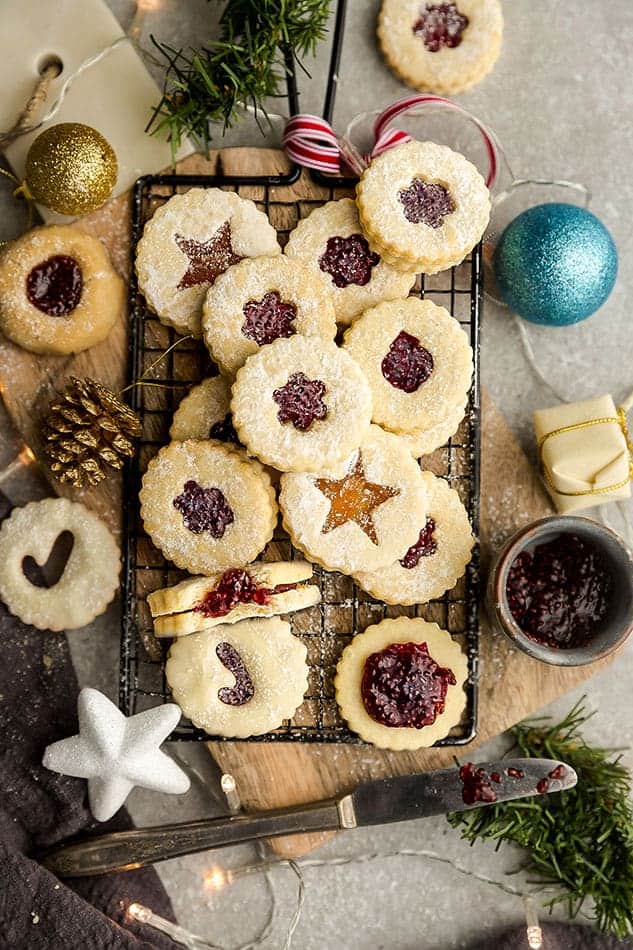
{"left": 492, "top": 203, "right": 618, "bottom": 327}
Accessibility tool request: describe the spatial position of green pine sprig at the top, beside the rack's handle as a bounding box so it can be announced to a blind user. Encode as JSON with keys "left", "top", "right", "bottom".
{"left": 148, "top": 0, "right": 330, "bottom": 155}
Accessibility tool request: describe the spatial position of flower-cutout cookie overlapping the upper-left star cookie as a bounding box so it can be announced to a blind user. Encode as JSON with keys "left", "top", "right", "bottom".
{"left": 202, "top": 255, "right": 336, "bottom": 375}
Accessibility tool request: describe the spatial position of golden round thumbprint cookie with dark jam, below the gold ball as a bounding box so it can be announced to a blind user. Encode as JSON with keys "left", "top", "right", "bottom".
{"left": 0, "top": 225, "right": 125, "bottom": 354}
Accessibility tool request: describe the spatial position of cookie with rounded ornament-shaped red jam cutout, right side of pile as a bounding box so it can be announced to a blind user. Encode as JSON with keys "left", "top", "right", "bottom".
{"left": 343, "top": 297, "right": 473, "bottom": 437}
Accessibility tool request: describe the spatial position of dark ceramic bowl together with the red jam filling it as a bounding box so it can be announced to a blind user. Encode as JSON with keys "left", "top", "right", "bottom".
{"left": 486, "top": 515, "right": 633, "bottom": 666}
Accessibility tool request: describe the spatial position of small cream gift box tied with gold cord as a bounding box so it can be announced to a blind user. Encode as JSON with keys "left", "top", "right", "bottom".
{"left": 534, "top": 395, "right": 633, "bottom": 513}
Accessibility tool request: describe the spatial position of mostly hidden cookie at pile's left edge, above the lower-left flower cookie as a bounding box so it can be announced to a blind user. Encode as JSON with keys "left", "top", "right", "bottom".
{"left": 169, "top": 376, "right": 240, "bottom": 446}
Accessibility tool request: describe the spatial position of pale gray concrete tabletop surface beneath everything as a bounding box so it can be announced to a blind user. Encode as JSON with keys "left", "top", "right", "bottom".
{"left": 1, "top": 0, "right": 633, "bottom": 950}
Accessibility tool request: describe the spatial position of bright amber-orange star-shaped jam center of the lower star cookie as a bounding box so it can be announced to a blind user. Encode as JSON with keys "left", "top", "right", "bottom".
{"left": 315, "top": 452, "right": 400, "bottom": 544}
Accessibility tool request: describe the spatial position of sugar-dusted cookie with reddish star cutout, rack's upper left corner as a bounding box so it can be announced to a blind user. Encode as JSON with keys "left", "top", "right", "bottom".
{"left": 136, "top": 188, "right": 281, "bottom": 336}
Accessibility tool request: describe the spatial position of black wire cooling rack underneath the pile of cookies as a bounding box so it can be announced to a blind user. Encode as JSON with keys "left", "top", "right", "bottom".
{"left": 120, "top": 4, "right": 482, "bottom": 745}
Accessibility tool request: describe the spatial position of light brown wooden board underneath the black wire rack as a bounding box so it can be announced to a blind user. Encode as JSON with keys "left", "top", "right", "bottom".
{"left": 0, "top": 149, "right": 608, "bottom": 856}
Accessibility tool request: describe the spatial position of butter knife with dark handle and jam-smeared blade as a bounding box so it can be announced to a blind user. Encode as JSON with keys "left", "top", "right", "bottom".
{"left": 41, "top": 759, "right": 577, "bottom": 877}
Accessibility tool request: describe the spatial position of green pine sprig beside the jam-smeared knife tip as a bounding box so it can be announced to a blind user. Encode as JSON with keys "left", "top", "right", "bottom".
{"left": 449, "top": 701, "right": 633, "bottom": 939}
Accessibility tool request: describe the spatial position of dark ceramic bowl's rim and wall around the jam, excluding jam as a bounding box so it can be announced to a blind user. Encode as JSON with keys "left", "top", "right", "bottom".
{"left": 486, "top": 515, "right": 633, "bottom": 666}
